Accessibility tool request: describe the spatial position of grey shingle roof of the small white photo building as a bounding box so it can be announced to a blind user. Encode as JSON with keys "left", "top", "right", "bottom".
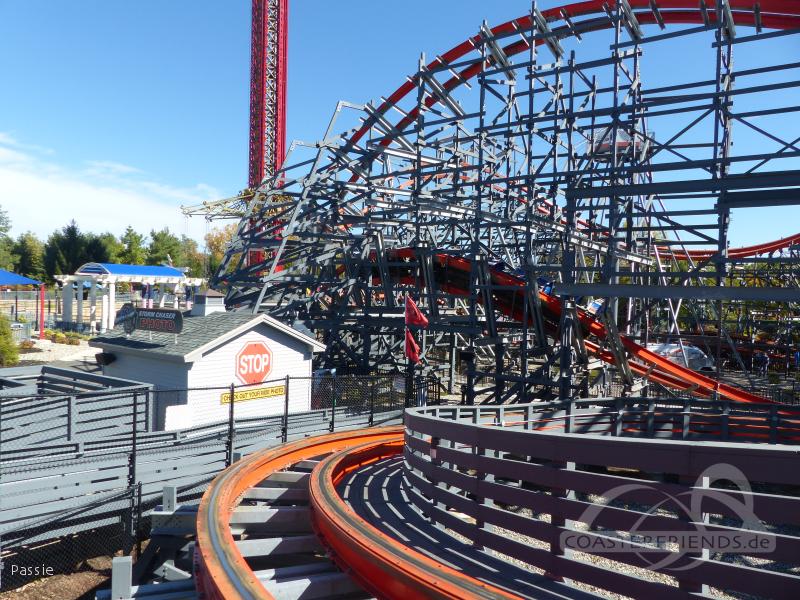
{"left": 91, "top": 312, "right": 259, "bottom": 357}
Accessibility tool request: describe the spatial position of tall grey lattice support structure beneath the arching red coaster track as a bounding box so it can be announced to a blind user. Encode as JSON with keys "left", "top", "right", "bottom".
{"left": 215, "top": 0, "right": 800, "bottom": 403}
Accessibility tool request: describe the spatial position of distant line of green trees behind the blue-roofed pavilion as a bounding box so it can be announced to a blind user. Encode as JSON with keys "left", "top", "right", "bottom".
{"left": 0, "top": 207, "right": 236, "bottom": 282}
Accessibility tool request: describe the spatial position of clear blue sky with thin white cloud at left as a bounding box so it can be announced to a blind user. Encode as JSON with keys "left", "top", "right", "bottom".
{"left": 0, "top": 0, "right": 797, "bottom": 243}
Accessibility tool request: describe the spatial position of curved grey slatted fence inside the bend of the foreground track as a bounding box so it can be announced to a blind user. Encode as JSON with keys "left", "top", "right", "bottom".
{"left": 404, "top": 399, "right": 800, "bottom": 598}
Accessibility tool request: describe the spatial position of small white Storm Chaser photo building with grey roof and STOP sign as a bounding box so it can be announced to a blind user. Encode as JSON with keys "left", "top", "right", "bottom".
{"left": 90, "top": 292, "right": 325, "bottom": 431}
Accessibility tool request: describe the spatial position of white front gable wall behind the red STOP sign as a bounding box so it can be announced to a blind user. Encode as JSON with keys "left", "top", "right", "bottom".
{"left": 186, "top": 323, "right": 312, "bottom": 425}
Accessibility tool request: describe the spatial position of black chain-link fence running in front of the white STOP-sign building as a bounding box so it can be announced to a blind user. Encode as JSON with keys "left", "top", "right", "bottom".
{"left": 0, "top": 375, "right": 424, "bottom": 590}
